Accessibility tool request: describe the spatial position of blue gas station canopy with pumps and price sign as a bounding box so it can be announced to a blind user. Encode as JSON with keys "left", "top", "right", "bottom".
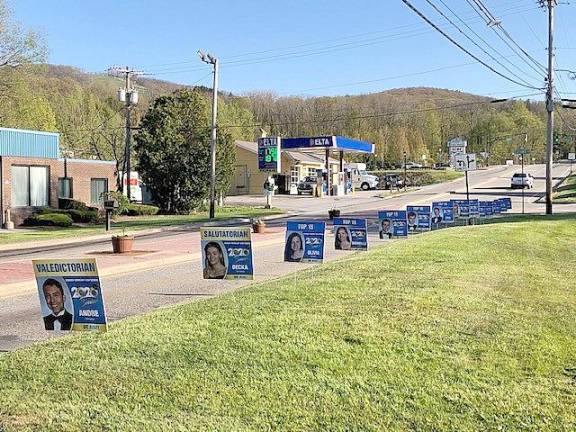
{"left": 258, "top": 136, "right": 374, "bottom": 195}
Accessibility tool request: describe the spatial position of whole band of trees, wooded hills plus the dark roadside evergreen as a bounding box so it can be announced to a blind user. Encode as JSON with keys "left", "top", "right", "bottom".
{"left": 0, "top": 0, "right": 576, "bottom": 212}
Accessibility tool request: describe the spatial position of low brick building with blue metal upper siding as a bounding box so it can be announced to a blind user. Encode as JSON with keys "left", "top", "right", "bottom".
{"left": 0, "top": 128, "right": 116, "bottom": 225}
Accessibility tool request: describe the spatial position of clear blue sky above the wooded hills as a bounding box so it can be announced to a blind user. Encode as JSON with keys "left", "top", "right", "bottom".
{"left": 8, "top": 0, "right": 576, "bottom": 97}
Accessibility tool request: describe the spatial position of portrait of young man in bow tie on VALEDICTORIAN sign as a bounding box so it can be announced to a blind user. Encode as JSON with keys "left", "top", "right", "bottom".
{"left": 40, "top": 278, "right": 74, "bottom": 331}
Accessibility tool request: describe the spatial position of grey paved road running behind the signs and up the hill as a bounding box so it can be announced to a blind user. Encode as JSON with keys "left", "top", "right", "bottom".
{"left": 0, "top": 165, "right": 576, "bottom": 351}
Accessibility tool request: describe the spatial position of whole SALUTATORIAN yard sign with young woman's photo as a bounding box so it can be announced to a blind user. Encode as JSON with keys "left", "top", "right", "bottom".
{"left": 200, "top": 227, "right": 254, "bottom": 279}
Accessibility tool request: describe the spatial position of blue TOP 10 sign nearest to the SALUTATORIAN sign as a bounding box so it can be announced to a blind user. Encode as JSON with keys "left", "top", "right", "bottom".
{"left": 284, "top": 221, "right": 326, "bottom": 262}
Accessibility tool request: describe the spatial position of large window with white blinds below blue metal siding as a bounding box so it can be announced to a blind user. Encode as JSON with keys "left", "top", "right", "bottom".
{"left": 12, "top": 166, "right": 48, "bottom": 207}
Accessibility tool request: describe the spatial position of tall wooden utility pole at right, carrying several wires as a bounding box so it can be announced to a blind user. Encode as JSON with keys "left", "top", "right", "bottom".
{"left": 538, "top": 0, "right": 557, "bottom": 214}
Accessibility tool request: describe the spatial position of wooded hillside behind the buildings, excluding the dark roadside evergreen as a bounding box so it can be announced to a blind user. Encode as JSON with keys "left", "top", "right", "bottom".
{"left": 0, "top": 65, "right": 574, "bottom": 169}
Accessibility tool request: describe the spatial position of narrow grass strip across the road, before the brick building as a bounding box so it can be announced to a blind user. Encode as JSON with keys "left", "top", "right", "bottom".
{"left": 0, "top": 206, "right": 282, "bottom": 244}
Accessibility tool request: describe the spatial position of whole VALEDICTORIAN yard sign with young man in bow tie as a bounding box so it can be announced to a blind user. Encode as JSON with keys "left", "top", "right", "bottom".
{"left": 32, "top": 258, "right": 107, "bottom": 332}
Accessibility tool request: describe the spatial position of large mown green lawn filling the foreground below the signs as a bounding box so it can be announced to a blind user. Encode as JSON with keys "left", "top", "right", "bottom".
{"left": 0, "top": 216, "right": 576, "bottom": 431}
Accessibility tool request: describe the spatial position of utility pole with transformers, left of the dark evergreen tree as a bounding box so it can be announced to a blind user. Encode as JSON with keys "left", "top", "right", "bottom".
{"left": 108, "top": 66, "right": 142, "bottom": 201}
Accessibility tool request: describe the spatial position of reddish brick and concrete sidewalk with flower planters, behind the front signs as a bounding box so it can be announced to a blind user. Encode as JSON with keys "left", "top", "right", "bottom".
{"left": 0, "top": 221, "right": 284, "bottom": 298}
